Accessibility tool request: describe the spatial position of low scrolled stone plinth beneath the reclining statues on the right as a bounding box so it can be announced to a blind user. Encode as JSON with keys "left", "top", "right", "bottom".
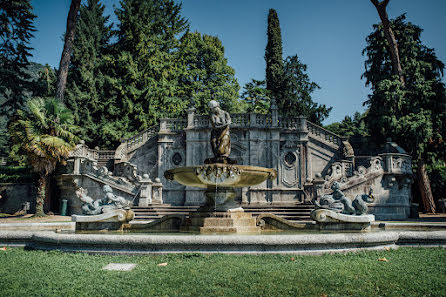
{"left": 311, "top": 209, "right": 375, "bottom": 230}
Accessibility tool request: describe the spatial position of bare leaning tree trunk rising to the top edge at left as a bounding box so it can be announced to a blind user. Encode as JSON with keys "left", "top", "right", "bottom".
{"left": 56, "top": 0, "right": 81, "bottom": 102}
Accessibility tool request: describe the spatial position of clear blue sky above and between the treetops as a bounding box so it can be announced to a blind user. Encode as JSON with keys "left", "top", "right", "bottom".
{"left": 31, "top": 0, "right": 446, "bottom": 124}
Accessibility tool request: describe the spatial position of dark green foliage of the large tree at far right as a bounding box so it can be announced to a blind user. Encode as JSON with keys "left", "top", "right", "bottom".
{"left": 363, "top": 15, "right": 446, "bottom": 161}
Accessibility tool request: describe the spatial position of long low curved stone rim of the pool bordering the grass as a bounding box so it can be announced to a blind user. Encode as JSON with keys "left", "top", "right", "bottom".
{"left": 0, "top": 230, "right": 446, "bottom": 254}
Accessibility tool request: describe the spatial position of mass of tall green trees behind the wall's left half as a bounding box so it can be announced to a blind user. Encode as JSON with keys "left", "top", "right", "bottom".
{"left": 61, "top": 0, "right": 242, "bottom": 148}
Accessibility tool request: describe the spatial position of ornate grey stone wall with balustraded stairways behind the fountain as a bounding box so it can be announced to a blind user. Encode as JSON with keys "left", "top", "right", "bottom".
{"left": 61, "top": 107, "right": 412, "bottom": 219}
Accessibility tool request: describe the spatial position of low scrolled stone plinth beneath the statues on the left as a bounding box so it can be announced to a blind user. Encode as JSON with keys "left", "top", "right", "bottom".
{"left": 71, "top": 209, "right": 135, "bottom": 231}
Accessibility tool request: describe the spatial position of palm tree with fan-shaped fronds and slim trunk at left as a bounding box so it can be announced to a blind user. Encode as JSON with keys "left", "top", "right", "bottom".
{"left": 8, "top": 98, "right": 78, "bottom": 216}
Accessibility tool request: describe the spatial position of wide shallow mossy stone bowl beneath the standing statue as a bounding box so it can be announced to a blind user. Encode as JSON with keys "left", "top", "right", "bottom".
{"left": 164, "top": 163, "right": 277, "bottom": 188}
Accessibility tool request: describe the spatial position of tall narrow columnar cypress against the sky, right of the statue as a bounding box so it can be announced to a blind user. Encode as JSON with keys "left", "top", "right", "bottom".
{"left": 265, "top": 8, "right": 284, "bottom": 101}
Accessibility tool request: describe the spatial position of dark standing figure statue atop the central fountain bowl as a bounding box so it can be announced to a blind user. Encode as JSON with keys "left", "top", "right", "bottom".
{"left": 205, "top": 100, "right": 235, "bottom": 164}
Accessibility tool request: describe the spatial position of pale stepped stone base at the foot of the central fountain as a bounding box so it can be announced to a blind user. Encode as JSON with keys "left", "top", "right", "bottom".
{"left": 186, "top": 208, "right": 260, "bottom": 234}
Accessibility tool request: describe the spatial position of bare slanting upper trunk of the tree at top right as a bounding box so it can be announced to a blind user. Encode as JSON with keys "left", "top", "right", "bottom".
{"left": 370, "top": 0, "right": 406, "bottom": 87}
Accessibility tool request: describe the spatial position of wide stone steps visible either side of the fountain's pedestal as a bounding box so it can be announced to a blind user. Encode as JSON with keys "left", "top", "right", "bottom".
{"left": 132, "top": 204, "right": 314, "bottom": 222}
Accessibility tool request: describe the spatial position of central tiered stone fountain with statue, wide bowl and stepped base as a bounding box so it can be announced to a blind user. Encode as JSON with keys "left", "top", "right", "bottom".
{"left": 164, "top": 100, "right": 277, "bottom": 233}
